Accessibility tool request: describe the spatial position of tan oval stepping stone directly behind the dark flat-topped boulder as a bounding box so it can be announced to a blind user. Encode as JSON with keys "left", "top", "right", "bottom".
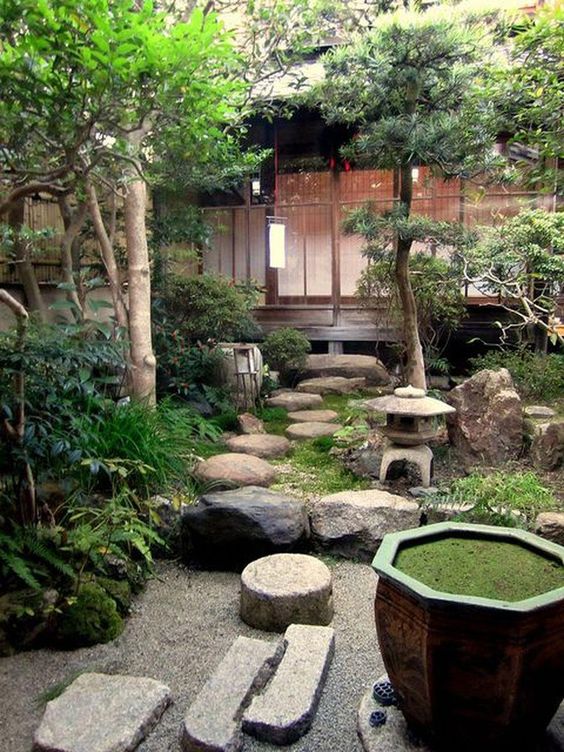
{"left": 195, "top": 452, "right": 276, "bottom": 488}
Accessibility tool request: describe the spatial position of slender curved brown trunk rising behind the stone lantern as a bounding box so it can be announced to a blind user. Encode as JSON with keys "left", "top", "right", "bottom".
{"left": 395, "top": 164, "right": 427, "bottom": 389}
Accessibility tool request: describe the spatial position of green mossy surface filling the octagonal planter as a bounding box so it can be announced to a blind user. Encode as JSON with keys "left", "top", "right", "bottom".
{"left": 394, "top": 538, "right": 564, "bottom": 601}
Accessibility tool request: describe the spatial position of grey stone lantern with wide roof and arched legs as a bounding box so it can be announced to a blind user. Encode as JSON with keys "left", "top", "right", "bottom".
{"left": 365, "top": 385, "right": 455, "bottom": 487}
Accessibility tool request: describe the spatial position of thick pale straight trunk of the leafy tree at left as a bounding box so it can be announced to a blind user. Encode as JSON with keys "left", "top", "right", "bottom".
{"left": 125, "top": 177, "right": 156, "bottom": 404}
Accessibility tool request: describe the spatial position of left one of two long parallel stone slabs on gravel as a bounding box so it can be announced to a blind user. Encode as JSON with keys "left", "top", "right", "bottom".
{"left": 181, "top": 637, "right": 284, "bottom": 752}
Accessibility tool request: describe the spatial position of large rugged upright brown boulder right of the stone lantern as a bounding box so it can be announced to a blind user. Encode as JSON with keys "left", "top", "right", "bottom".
{"left": 446, "top": 368, "right": 523, "bottom": 466}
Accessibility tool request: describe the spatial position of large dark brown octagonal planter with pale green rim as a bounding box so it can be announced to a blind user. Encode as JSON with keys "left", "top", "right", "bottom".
{"left": 372, "top": 523, "right": 564, "bottom": 752}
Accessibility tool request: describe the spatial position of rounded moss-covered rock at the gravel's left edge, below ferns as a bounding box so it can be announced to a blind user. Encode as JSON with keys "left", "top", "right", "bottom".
{"left": 58, "top": 582, "right": 124, "bottom": 648}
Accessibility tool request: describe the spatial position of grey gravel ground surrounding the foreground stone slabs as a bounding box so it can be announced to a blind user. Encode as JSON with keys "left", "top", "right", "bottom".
{"left": 0, "top": 561, "right": 383, "bottom": 752}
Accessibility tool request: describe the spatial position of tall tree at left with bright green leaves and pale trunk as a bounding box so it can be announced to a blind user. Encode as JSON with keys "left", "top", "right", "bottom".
{"left": 0, "top": 0, "right": 253, "bottom": 399}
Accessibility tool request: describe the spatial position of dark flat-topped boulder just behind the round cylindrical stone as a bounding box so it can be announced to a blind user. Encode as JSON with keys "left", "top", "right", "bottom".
{"left": 182, "top": 486, "right": 309, "bottom": 567}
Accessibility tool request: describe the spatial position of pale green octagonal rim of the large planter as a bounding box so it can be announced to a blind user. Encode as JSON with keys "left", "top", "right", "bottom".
{"left": 372, "top": 522, "right": 564, "bottom": 613}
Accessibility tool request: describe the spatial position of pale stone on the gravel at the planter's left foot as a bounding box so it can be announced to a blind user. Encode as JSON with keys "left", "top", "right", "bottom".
{"left": 357, "top": 675, "right": 432, "bottom": 752}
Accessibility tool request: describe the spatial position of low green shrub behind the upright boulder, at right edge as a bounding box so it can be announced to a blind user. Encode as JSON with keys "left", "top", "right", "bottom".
{"left": 471, "top": 348, "right": 564, "bottom": 402}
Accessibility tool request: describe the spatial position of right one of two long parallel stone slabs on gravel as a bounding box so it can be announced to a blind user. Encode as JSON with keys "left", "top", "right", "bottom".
{"left": 243, "top": 624, "right": 335, "bottom": 744}
